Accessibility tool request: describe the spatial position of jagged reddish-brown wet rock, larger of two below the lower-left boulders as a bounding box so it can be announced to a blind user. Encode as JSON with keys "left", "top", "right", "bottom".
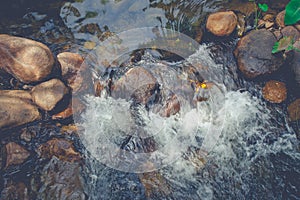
{"left": 38, "top": 138, "right": 81, "bottom": 162}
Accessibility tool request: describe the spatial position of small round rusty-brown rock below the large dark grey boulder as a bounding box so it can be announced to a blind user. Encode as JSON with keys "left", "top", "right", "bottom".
{"left": 262, "top": 80, "right": 287, "bottom": 103}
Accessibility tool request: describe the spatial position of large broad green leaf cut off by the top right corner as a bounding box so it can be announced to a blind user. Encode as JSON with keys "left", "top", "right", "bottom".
{"left": 284, "top": 0, "right": 300, "bottom": 25}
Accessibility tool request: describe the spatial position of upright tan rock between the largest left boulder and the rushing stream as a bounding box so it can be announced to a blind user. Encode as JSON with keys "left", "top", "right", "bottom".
{"left": 57, "top": 52, "right": 86, "bottom": 92}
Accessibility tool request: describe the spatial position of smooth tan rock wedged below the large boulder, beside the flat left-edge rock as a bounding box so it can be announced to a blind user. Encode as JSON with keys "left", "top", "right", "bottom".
{"left": 31, "top": 79, "right": 68, "bottom": 111}
